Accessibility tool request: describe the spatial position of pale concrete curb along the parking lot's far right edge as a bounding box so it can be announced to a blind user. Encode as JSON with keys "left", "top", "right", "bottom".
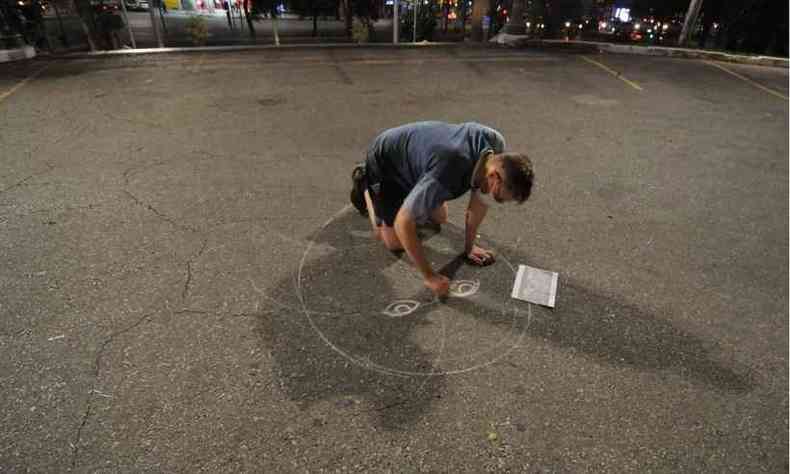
{"left": 525, "top": 40, "right": 790, "bottom": 68}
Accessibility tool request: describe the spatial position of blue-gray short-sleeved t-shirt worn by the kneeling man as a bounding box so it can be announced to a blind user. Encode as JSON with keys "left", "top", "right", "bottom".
{"left": 368, "top": 122, "right": 505, "bottom": 224}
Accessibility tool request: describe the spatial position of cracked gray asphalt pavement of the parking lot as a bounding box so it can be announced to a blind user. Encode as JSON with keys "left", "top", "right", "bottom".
{"left": 0, "top": 45, "right": 789, "bottom": 473}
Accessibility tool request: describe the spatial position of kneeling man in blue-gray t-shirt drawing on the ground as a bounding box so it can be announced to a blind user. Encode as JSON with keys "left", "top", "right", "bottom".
{"left": 351, "top": 122, "right": 533, "bottom": 297}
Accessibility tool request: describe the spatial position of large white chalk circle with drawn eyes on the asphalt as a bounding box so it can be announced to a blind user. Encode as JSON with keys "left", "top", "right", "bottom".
{"left": 294, "top": 205, "right": 532, "bottom": 377}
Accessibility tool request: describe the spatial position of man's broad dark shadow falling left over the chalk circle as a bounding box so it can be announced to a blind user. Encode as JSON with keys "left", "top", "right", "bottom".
{"left": 257, "top": 211, "right": 452, "bottom": 429}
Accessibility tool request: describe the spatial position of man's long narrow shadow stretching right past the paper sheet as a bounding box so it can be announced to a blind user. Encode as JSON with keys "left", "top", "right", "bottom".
{"left": 434, "top": 226, "right": 757, "bottom": 392}
